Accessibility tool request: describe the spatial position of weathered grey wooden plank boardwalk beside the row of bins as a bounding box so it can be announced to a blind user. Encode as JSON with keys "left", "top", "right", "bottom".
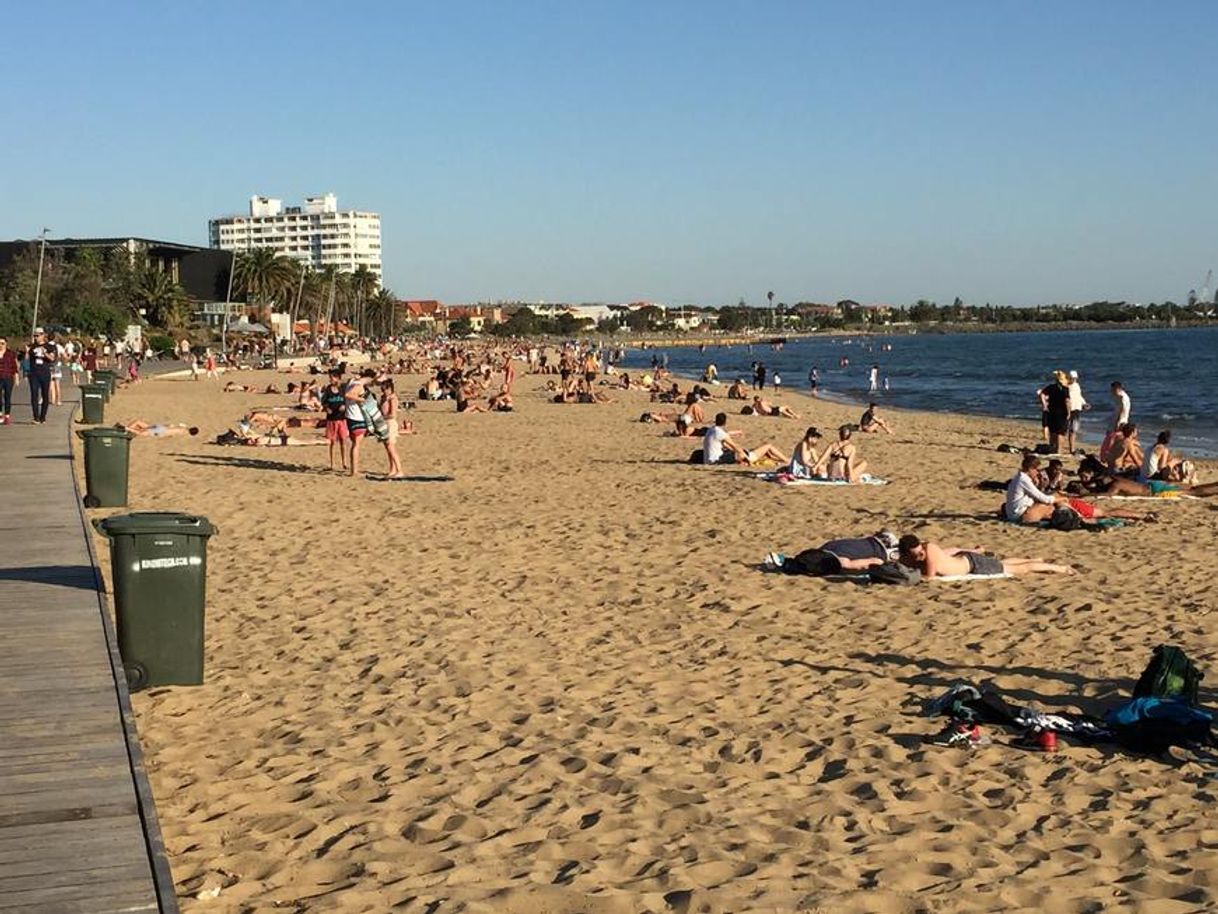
{"left": 0, "top": 384, "right": 178, "bottom": 914}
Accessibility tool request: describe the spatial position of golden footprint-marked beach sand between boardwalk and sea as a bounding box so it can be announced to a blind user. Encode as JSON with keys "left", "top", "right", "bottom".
{"left": 85, "top": 372, "right": 1218, "bottom": 914}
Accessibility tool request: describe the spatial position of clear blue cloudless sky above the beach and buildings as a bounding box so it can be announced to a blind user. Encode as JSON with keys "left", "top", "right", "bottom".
{"left": 0, "top": 0, "right": 1218, "bottom": 305}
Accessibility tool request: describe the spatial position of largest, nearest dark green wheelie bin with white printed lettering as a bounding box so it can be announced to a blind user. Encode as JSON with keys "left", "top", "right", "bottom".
{"left": 94, "top": 511, "right": 219, "bottom": 691}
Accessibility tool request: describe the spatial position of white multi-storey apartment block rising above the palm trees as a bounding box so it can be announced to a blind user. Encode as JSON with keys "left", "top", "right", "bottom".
{"left": 208, "top": 194, "right": 381, "bottom": 284}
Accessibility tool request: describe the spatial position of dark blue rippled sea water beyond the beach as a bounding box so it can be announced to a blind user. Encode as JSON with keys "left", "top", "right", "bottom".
{"left": 624, "top": 327, "right": 1218, "bottom": 457}
